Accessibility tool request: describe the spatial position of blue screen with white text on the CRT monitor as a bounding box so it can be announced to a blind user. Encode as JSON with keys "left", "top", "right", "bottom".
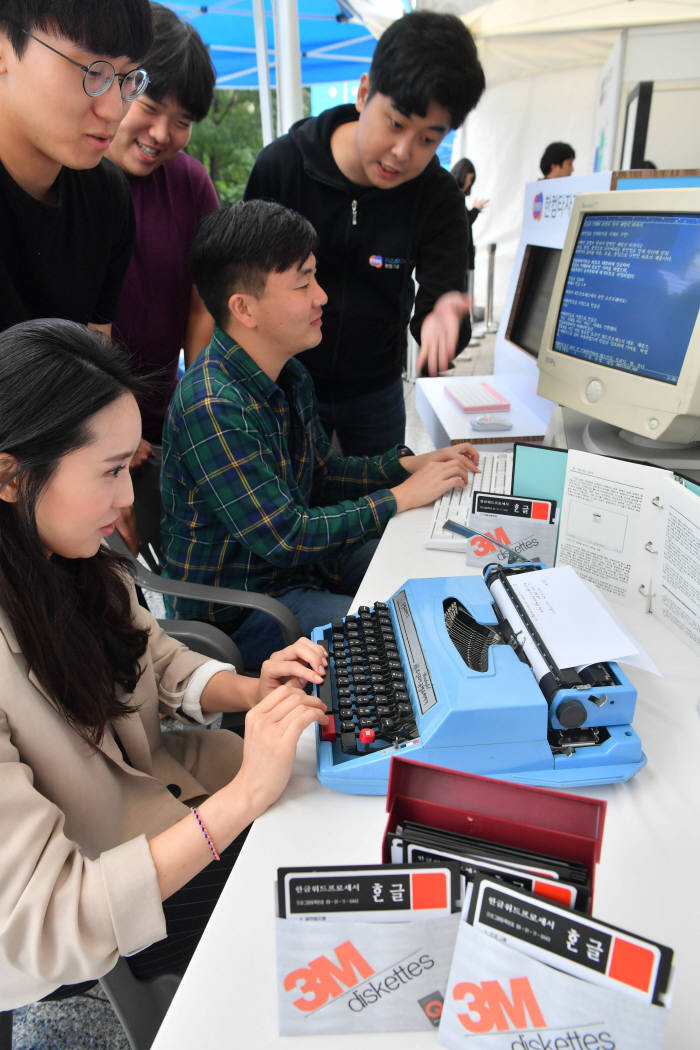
{"left": 554, "top": 213, "right": 700, "bottom": 383}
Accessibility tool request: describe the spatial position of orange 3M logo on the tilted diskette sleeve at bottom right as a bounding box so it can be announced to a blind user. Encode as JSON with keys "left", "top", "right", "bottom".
{"left": 452, "top": 978, "right": 547, "bottom": 1032}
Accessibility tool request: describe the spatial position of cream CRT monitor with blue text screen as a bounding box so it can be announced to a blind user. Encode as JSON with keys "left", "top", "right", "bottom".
{"left": 537, "top": 188, "right": 700, "bottom": 461}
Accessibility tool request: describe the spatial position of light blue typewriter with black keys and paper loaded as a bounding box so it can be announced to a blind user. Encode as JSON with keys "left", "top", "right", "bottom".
{"left": 312, "top": 563, "right": 646, "bottom": 795}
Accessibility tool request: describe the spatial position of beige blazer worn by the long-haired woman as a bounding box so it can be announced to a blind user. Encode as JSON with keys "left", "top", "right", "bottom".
{"left": 0, "top": 599, "right": 242, "bottom": 1009}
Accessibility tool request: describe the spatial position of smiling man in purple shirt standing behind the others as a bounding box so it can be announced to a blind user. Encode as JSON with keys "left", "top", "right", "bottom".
{"left": 107, "top": 3, "right": 218, "bottom": 466}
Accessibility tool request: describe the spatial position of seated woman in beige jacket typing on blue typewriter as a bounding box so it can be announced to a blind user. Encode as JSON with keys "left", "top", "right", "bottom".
{"left": 0, "top": 320, "right": 326, "bottom": 1009}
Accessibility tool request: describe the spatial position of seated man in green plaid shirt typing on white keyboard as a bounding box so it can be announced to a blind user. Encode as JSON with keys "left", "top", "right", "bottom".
{"left": 162, "top": 201, "right": 479, "bottom": 668}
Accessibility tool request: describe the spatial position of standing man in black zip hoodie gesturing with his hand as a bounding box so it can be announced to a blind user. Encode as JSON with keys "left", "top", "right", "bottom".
{"left": 246, "top": 12, "right": 484, "bottom": 456}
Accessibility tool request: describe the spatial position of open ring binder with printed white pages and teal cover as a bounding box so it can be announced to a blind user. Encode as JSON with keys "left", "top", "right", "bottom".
{"left": 512, "top": 444, "right": 700, "bottom": 650}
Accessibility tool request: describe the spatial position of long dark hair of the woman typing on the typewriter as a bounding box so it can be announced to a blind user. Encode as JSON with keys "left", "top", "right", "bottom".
{"left": 0, "top": 319, "right": 148, "bottom": 742}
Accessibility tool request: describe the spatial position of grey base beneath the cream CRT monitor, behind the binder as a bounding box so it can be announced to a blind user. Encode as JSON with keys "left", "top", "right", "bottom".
{"left": 545, "top": 407, "right": 700, "bottom": 481}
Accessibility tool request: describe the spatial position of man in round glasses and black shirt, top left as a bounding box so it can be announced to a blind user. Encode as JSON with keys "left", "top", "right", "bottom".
{"left": 0, "top": 0, "right": 152, "bottom": 332}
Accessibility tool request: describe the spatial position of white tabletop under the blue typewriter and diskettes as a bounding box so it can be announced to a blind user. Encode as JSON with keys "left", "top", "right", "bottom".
{"left": 152, "top": 508, "right": 700, "bottom": 1050}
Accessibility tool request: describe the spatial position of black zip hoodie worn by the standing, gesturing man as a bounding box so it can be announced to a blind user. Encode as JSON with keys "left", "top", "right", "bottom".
{"left": 246, "top": 105, "right": 469, "bottom": 401}
